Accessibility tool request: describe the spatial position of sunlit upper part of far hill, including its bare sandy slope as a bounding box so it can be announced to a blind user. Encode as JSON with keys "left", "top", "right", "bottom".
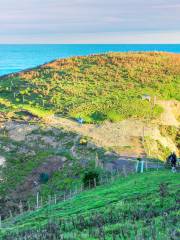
{"left": 0, "top": 52, "right": 180, "bottom": 159}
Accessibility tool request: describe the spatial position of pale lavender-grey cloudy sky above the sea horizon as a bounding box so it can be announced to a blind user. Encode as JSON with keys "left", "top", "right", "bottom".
{"left": 0, "top": 0, "right": 180, "bottom": 43}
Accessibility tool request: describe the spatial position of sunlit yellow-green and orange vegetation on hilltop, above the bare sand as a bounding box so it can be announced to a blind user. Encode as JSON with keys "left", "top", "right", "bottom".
{"left": 0, "top": 53, "right": 180, "bottom": 122}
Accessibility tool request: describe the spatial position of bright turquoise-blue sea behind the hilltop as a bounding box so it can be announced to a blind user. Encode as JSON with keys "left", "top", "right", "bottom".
{"left": 0, "top": 44, "right": 180, "bottom": 76}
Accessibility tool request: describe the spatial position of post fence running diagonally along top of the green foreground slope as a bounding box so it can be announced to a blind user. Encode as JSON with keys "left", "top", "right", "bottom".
{"left": 0, "top": 161, "right": 164, "bottom": 229}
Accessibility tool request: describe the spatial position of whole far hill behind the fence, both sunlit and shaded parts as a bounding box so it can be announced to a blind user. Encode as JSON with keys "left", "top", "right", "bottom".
{"left": 0, "top": 53, "right": 180, "bottom": 236}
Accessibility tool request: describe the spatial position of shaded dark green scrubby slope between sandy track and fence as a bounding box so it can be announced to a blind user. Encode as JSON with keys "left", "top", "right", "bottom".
{"left": 0, "top": 121, "right": 118, "bottom": 218}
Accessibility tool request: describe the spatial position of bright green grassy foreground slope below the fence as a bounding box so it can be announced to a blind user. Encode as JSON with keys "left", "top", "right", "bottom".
{"left": 0, "top": 170, "right": 180, "bottom": 240}
